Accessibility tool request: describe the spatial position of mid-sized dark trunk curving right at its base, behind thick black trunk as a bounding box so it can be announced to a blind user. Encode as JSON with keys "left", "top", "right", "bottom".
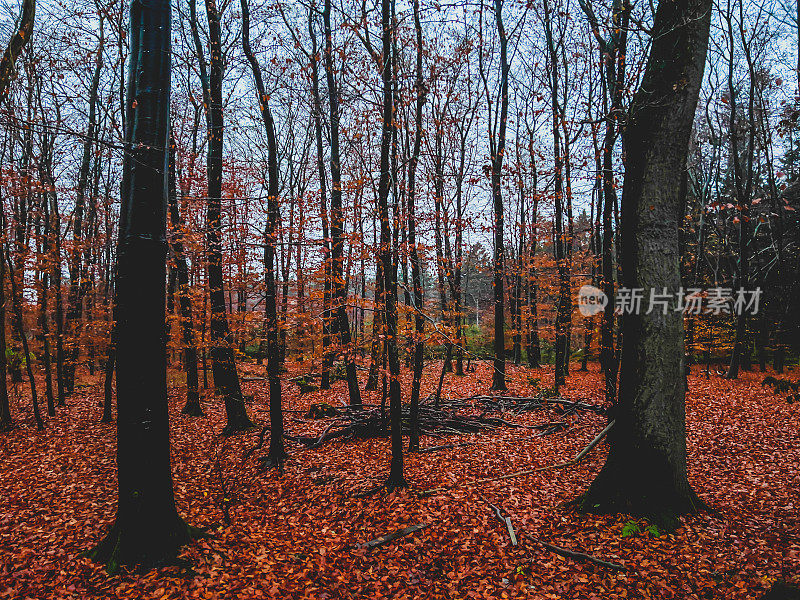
{"left": 195, "top": 0, "right": 253, "bottom": 435}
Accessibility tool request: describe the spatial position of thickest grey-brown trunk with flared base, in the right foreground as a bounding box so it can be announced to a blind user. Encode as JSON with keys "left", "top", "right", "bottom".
{"left": 578, "top": 0, "right": 712, "bottom": 530}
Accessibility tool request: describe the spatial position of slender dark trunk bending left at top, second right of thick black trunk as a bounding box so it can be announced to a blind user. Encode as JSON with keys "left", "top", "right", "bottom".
{"left": 241, "top": 0, "right": 286, "bottom": 469}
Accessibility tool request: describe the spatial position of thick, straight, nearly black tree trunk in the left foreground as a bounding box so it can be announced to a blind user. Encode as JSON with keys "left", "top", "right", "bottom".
{"left": 86, "top": 0, "right": 196, "bottom": 572}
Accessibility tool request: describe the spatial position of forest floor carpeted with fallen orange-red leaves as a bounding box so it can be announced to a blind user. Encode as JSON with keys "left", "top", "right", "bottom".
{"left": 0, "top": 364, "right": 800, "bottom": 600}
